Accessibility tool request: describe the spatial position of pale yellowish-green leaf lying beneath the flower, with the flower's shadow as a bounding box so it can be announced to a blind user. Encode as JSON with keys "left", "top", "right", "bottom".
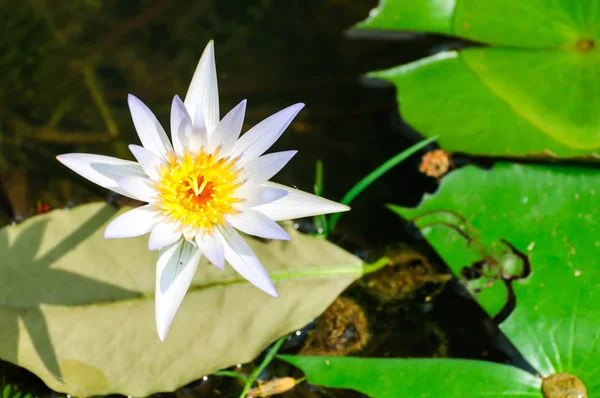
{"left": 0, "top": 203, "right": 362, "bottom": 396}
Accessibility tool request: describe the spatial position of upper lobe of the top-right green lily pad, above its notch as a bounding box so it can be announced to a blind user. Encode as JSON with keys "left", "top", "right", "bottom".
{"left": 356, "top": 0, "right": 600, "bottom": 49}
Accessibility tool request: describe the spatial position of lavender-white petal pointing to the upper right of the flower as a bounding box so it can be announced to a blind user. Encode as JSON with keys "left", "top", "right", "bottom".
{"left": 231, "top": 104, "right": 304, "bottom": 165}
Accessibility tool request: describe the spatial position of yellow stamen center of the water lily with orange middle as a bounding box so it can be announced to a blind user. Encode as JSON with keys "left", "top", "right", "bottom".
{"left": 155, "top": 148, "right": 244, "bottom": 234}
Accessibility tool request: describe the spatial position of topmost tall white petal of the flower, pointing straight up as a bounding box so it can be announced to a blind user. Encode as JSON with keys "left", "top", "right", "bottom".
{"left": 184, "top": 40, "right": 219, "bottom": 137}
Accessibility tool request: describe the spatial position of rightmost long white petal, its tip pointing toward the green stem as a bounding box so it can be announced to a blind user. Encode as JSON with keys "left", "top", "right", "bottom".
{"left": 253, "top": 182, "right": 350, "bottom": 221}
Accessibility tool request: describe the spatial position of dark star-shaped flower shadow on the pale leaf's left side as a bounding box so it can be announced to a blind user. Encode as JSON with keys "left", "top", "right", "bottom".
{"left": 0, "top": 207, "right": 140, "bottom": 379}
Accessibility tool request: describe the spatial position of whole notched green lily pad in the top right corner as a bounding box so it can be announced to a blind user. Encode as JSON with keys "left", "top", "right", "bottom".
{"left": 358, "top": 0, "right": 600, "bottom": 157}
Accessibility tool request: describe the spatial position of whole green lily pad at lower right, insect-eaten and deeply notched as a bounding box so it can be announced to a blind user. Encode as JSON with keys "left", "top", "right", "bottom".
{"left": 284, "top": 163, "right": 600, "bottom": 398}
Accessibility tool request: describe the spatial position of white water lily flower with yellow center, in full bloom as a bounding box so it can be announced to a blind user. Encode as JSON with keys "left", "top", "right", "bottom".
{"left": 57, "top": 41, "right": 349, "bottom": 341}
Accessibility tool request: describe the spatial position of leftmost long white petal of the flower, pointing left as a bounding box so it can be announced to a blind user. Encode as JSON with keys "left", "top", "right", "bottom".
{"left": 56, "top": 153, "right": 146, "bottom": 199}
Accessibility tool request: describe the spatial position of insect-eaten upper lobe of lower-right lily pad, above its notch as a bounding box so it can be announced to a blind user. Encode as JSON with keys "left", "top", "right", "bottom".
{"left": 394, "top": 164, "right": 600, "bottom": 396}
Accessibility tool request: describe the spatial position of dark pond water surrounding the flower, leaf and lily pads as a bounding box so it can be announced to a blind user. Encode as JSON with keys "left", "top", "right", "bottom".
{"left": 0, "top": 0, "right": 524, "bottom": 397}
